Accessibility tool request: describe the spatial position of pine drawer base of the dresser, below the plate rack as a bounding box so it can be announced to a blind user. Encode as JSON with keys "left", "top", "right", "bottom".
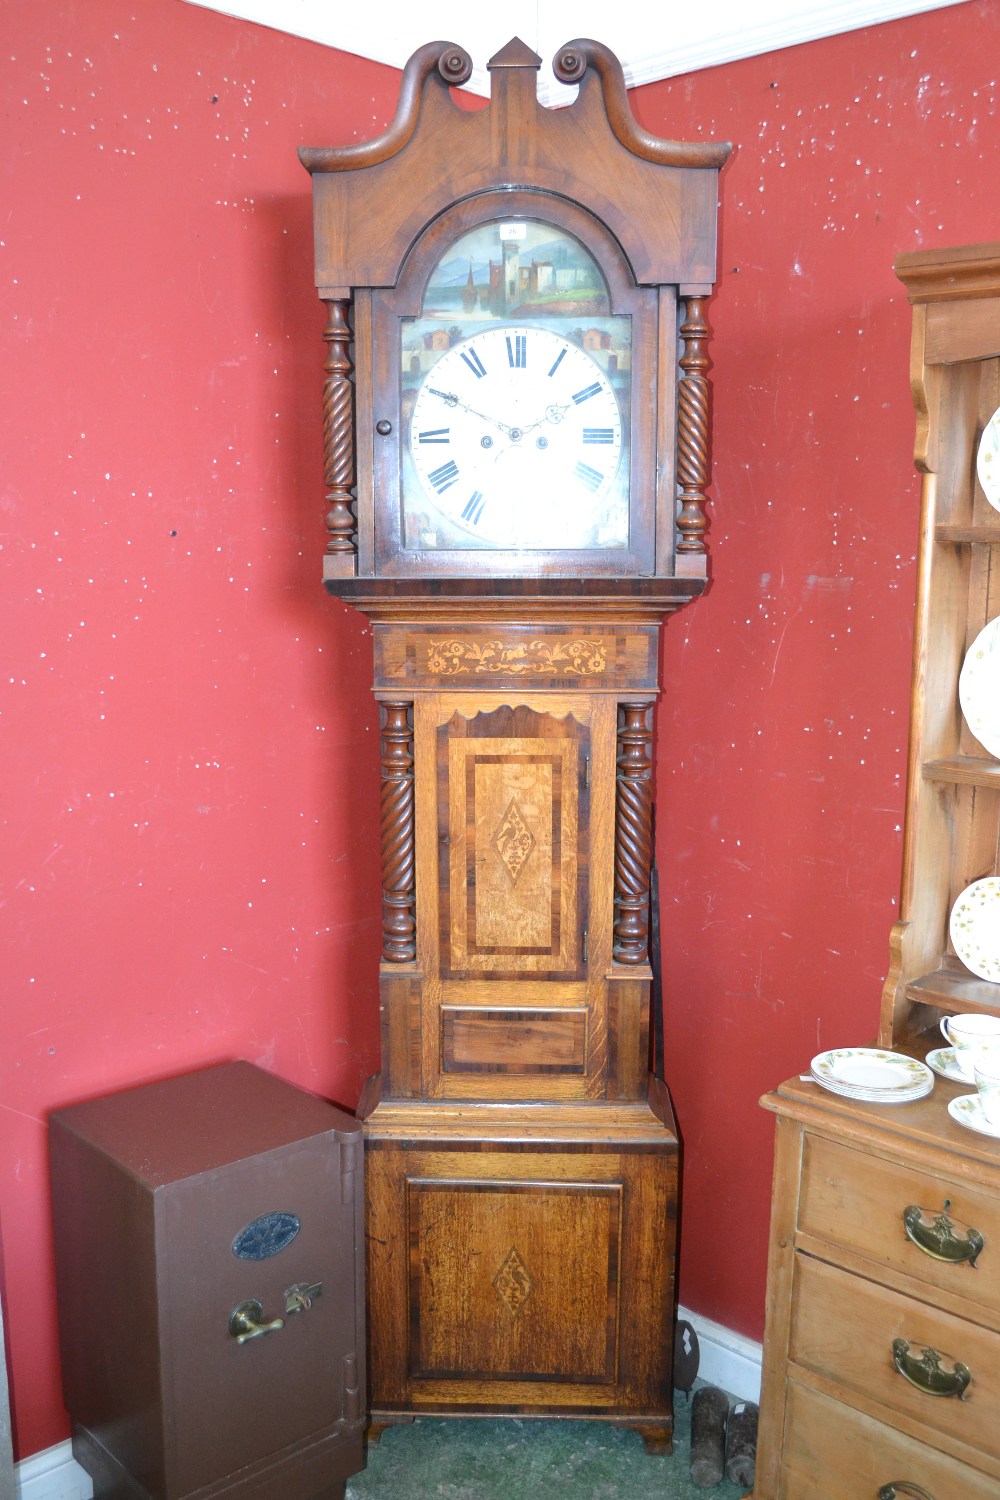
{"left": 754, "top": 1079, "right": 1000, "bottom": 1500}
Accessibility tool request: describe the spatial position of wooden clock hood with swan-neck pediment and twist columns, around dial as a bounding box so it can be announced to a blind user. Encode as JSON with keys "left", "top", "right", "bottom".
{"left": 300, "top": 41, "right": 729, "bottom": 603}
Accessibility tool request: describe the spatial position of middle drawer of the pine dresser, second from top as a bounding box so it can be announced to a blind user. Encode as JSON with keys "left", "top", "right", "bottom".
{"left": 789, "top": 1254, "right": 1000, "bottom": 1475}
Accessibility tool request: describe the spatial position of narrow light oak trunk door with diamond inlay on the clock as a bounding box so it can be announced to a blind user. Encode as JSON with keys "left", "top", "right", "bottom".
{"left": 438, "top": 705, "right": 589, "bottom": 978}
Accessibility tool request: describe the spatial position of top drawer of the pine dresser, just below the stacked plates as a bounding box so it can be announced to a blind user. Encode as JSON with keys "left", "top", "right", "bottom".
{"left": 798, "top": 1134, "right": 1000, "bottom": 1326}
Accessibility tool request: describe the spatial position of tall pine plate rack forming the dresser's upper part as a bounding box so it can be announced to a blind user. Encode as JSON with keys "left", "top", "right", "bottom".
{"left": 879, "top": 245, "right": 1000, "bottom": 1047}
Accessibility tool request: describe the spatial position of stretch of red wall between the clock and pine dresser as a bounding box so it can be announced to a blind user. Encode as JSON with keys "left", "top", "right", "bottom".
{"left": 633, "top": 0, "right": 1000, "bottom": 1338}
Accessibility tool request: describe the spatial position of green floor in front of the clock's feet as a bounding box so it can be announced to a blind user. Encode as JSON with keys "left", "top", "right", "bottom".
{"left": 348, "top": 1392, "right": 747, "bottom": 1500}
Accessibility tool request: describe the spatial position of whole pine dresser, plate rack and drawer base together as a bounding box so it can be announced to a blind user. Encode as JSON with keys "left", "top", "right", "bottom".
{"left": 754, "top": 245, "right": 1000, "bottom": 1500}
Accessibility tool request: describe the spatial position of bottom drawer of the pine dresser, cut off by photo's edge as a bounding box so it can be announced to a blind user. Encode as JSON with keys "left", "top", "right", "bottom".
{"left": 780, "top": 1380, "right": 997, "bottom": 1500}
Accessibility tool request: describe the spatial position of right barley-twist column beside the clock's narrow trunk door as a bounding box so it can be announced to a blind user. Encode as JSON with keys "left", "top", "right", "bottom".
{"left": 612, "top": 702, "right": 652, "bottom": 963}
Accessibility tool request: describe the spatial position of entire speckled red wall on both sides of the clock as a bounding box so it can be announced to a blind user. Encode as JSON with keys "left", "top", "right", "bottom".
{"left": 0, "top": 0, "right": 1000, "bottom": 1454}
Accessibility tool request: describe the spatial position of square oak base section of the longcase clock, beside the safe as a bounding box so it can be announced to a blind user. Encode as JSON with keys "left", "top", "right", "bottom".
{"left": 366, "top": 1103, "right": 678, "bottom": 1437}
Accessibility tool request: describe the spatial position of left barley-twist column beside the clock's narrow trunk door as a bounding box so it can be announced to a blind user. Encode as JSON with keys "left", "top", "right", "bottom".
{"left": 381, "top": 704, "right": 417, "bottom": 963}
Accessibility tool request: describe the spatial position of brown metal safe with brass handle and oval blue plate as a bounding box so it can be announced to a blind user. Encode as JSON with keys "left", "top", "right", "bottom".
{"left": 49, "top": 1062, "right": 364, "bottom": 1500}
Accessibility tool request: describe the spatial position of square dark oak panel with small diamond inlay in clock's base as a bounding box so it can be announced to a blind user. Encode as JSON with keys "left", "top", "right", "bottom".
{"left": 406, "top": 1179, "right": 622, "bottom": 1385}
